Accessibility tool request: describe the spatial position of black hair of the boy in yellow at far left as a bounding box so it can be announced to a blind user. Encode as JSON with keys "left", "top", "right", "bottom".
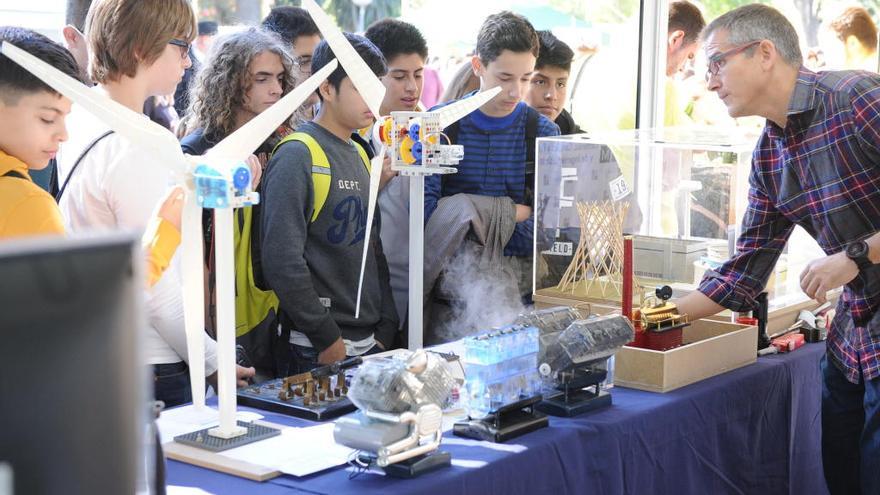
{"left": 0, "top": 26, "right": 81, "bottom": 104}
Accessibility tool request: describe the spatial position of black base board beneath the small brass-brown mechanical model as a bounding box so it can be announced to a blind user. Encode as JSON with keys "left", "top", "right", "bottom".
{"left": 237, "top": 378, "right": 357, "bottom": 421}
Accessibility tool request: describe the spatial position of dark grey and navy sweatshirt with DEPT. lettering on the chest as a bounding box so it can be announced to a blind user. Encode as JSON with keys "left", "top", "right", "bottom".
{"left": 261, "top": 122, "right": 398, "bottom": 352}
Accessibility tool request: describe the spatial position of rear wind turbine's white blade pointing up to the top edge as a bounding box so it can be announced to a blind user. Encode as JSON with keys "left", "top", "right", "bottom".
{"left": 302, "top": 0, "right": 385, "bottom": 119}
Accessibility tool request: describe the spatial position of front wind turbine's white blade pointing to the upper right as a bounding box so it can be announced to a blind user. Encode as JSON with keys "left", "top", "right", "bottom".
{"left": 201, "top": 60, "right": 338, "bottom": 165}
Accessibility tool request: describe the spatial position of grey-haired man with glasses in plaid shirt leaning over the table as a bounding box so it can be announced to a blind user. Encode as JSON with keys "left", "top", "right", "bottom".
{"left": 678, "top": 4, "right": 880, "bottom": 494}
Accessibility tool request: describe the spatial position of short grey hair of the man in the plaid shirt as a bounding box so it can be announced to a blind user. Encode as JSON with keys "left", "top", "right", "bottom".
{"left": 700, "top": 4, "right": 804, "bottom": 67}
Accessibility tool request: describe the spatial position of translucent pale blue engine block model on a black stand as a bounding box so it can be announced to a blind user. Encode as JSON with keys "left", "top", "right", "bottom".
{"left": 453, "top": 325, "right": 548, "bottom": 442}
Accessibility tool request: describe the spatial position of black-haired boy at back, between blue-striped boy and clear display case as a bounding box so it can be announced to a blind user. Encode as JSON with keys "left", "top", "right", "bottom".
{"left": 525, "top": 31, "right": 583, "bottom": 136}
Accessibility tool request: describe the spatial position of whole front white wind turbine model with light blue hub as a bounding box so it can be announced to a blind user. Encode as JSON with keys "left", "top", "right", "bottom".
{"left": 0, "top": 42, "right": 337, "bottom": 439}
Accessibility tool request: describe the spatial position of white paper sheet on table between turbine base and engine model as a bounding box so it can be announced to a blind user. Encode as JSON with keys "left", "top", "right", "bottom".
{"left": 220, "top": 423, "right": 354, "bottom": 476}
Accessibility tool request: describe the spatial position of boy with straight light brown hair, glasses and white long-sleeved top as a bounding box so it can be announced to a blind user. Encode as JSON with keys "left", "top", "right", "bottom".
{"left": 58, "top": 0, "right": 253, "bottom": 406}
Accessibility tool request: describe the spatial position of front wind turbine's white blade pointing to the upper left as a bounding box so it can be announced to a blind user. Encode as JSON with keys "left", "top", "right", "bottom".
{"left": 0, "top": 41, "right": 187, "bottom": 174}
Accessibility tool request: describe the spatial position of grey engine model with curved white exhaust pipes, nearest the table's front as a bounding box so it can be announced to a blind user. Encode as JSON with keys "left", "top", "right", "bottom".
{"left": 333, "top": 350, "right": 457, "bottom": 478}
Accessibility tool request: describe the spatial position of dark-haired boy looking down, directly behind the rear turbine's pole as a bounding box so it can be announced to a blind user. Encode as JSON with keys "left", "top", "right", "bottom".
{"left": 364, "top": 19, "right": 428, "bottom": 343}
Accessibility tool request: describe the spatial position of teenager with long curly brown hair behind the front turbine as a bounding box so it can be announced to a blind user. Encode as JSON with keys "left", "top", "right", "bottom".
{"left": 181, "top": 28, "right": 295, "bottom": 382}
